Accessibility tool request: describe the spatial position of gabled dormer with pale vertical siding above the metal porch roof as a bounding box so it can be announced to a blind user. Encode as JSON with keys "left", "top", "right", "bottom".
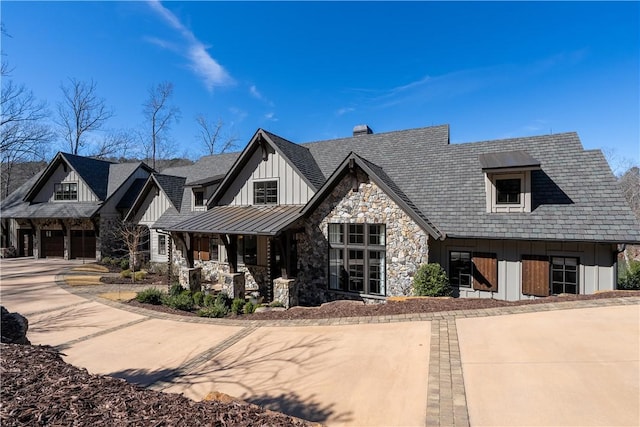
{"left": 207, "top": 129, "right": 324, "bottom": 207}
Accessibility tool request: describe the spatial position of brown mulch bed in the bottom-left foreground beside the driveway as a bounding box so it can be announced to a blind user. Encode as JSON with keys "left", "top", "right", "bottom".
{"left": 0, "top": 344, "right": 313, "bottom": 427}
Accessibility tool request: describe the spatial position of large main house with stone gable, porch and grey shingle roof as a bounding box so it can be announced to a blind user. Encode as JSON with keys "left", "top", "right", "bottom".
{"left": 127, "top": 125, "right": 640, "bottom": 305}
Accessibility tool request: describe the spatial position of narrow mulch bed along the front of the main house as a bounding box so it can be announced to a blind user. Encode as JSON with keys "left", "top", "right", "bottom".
{"left": 129, "top": 291, "right": 640, "bottom": 320}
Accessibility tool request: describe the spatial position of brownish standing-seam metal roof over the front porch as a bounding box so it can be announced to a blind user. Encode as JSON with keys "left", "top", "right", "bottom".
{"left": 166, "top": 205, "right": 303, "bottom": 236}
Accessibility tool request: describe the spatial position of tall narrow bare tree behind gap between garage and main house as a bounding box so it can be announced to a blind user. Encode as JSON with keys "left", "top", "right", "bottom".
{"left": 143, "top": 82, "right": 180, "bottom": 169}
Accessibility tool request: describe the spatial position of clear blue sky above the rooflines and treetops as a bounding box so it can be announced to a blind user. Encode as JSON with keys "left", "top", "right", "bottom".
{"left": 0, "top": 1, "right": 640, "bottom": 172}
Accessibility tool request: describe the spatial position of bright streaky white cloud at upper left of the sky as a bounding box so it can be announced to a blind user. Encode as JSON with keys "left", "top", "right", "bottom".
{"left": 147, "top": 0, "right": 233, "bottom": 90}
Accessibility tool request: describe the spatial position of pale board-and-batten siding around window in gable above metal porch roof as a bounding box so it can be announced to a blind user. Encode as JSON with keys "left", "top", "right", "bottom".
{"left": 220, "top": 150, "right": 314, "bottom": 206}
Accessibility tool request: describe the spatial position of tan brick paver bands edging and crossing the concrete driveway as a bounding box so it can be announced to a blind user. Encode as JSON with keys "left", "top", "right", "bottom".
{"left": 56, "top": 274, "right": 640, "bottom": 427}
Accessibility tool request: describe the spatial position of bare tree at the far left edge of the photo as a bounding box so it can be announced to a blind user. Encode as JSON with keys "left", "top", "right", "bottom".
{"left": 0, "top": 80, "right": 54, "bottom": 197}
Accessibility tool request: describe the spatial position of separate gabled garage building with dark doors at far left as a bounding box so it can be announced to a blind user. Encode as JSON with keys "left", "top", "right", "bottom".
{"left": 0, "top": 153, "right": 152, "bottom": 260}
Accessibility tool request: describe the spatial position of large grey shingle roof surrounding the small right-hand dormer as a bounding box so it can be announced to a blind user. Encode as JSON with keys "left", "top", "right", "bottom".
{"left": 296, "top": 126, "right": 640, "bottom": 242}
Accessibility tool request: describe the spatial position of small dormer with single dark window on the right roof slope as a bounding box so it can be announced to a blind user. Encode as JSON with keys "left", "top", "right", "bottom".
{"left": 478, "top": 150, "right": 540, "bottom": 213}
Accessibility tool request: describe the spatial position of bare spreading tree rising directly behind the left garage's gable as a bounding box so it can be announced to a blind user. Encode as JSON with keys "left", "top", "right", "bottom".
{"left": 58, "top": 78, "right": 114, "bottom": 154}
